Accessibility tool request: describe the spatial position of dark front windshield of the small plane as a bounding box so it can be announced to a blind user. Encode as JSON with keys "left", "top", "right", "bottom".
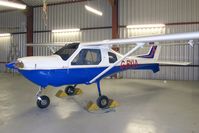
{"left": 55, "top": 43, "right": 79, "bottom": 60}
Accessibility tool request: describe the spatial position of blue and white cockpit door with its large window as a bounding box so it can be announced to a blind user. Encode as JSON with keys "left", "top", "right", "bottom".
{"left": 70, "top": 48, "right": 102, "bottom": 82}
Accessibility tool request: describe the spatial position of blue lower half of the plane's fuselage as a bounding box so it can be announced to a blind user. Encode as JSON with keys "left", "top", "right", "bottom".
{"left": 19, "top": 64, "right": 159, "bottom": 87}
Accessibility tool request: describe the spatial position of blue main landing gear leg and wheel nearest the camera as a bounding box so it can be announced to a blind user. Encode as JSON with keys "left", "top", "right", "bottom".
{"left": 97, "top": 81, "right": 109, "bottom": 109}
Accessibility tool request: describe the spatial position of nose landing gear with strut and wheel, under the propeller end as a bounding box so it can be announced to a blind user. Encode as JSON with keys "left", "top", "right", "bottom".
{"left": 36, "top": 87, "right": 50, "bottom": 109}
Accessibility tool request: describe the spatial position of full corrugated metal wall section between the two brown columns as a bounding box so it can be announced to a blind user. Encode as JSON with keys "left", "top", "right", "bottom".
{"left": 31, "top": 0, "right": 112, "bottom": 55}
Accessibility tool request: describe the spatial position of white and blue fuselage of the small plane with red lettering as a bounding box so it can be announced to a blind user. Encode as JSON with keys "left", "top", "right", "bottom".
{"left": 8, "top": 44, "right": 159, "bottom": 88}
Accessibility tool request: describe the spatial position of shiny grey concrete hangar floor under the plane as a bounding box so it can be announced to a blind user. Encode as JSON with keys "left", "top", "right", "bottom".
{"left": 0, "top": 74, "right": 199, "bottom": 133}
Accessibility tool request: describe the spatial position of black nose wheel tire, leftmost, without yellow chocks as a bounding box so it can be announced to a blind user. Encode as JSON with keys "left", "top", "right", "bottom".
{"left": 37, "top": 95, "right": 50, "bottom": 109}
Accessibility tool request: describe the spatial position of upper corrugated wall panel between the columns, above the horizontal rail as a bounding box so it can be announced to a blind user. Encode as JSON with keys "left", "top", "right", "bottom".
{"left": 34, "top": 0, "right": 111, "bottom": 31}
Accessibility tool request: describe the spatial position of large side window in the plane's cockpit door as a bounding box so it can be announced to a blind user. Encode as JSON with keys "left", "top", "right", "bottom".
{"left": 71, "top": 49, "right": 102, "bottom": 65}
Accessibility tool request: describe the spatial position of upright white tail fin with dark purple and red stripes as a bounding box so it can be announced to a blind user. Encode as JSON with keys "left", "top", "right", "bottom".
{"left": 138, "top": 45, "right": 161, "bottom": 60}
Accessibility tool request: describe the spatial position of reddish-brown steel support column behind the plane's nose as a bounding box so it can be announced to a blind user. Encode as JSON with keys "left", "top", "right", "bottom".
{"left": 26, "top": 7, "right": 33, "bottom": 56}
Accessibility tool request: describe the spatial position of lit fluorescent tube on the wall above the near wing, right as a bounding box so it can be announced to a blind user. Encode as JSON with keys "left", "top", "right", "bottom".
{"left": 126, "top": 24, "right": 165, "bottom": 29}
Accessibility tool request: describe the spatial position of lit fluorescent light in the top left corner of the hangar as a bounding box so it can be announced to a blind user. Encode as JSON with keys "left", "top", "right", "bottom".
{"left": 0, "top": 0, "right": 26, "bottom": 9}
